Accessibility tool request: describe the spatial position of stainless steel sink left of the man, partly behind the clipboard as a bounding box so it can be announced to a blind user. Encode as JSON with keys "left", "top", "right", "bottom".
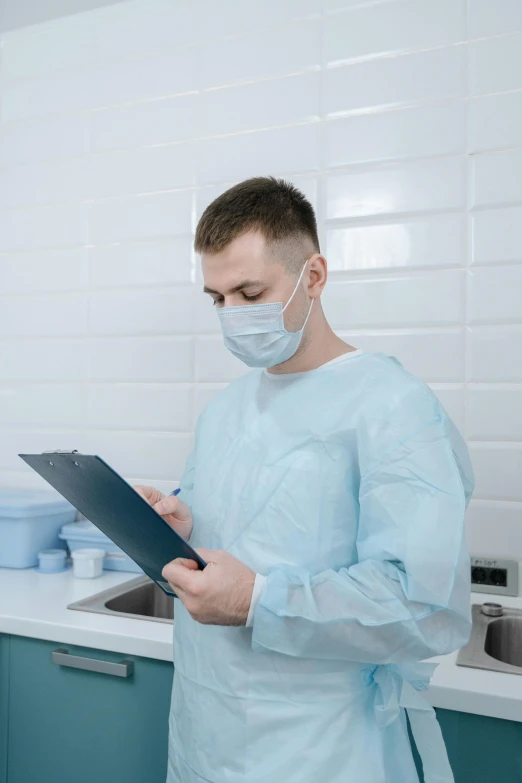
{"left": 67, "top": 576, "right": 174, "bottom": 623}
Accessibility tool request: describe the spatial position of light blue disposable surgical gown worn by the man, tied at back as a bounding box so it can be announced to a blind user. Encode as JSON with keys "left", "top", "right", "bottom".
{"left": 168, "top": 352, "right": 473, "bottom": 783}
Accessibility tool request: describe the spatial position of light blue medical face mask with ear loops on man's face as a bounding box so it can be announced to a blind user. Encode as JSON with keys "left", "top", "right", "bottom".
{"left": 218, "top": 262, "right": 314, "bottom": 367}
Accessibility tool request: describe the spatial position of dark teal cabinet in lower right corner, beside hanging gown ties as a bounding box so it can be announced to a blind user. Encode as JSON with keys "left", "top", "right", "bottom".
{"left": 408, "top": 709, "right": 522, "bottom": 783}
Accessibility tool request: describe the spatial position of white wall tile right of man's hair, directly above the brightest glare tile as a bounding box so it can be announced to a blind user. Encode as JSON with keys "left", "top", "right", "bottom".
{"left": 326, "top": 158, "right": 465, "bottom": 218}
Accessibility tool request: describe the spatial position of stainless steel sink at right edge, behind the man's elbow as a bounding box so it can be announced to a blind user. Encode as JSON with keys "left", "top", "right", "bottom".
{"left": 457, "top": 603, "right": 522, "bottom": 674}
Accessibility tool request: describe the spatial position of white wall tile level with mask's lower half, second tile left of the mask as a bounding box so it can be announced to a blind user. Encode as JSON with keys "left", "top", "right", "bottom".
{"left": 89, "top": 335, "right": 192, "bottom": 383}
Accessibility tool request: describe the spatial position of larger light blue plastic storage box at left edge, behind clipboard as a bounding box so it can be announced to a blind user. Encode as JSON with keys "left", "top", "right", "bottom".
{"left": 0, "top": 487, "right": 76, "bottom": 568}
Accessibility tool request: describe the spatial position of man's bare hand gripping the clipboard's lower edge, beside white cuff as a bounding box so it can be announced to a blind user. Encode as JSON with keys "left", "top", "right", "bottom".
{"left": 162, "top": 549, "right": 256, "bottom": 625}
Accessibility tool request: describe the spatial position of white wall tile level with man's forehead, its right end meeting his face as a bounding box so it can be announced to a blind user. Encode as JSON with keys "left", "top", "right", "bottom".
{"left": 88, "top": 237, "right": 192, "bottom": 288}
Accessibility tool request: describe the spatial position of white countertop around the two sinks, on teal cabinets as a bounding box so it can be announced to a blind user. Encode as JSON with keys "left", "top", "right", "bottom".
{"left": 0, "top": 568, "right": 522, "bottom": 722}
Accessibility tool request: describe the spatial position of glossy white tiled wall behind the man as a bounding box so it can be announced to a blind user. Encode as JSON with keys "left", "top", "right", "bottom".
{"left": 0, "top": 0, "right": 522, "bottom": 559}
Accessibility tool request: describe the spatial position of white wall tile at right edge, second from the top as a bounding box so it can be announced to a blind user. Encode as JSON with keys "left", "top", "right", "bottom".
{"left": 469, "top": 33, "right": 522, "bottom": 95}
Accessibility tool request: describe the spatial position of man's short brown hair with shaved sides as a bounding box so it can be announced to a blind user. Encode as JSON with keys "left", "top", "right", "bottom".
{"left": 194, "top": 177, "right": 321, "bottom": 267}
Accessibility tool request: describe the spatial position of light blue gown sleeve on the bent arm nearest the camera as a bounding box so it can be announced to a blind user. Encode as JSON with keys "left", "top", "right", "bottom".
{"left": 252, "top": 410, "right": 473, "bottom": 664}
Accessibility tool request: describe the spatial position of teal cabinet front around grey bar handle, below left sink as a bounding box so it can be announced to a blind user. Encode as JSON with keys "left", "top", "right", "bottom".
{"left": 8, "top": 636, "right": 173, "bottom": 783}
